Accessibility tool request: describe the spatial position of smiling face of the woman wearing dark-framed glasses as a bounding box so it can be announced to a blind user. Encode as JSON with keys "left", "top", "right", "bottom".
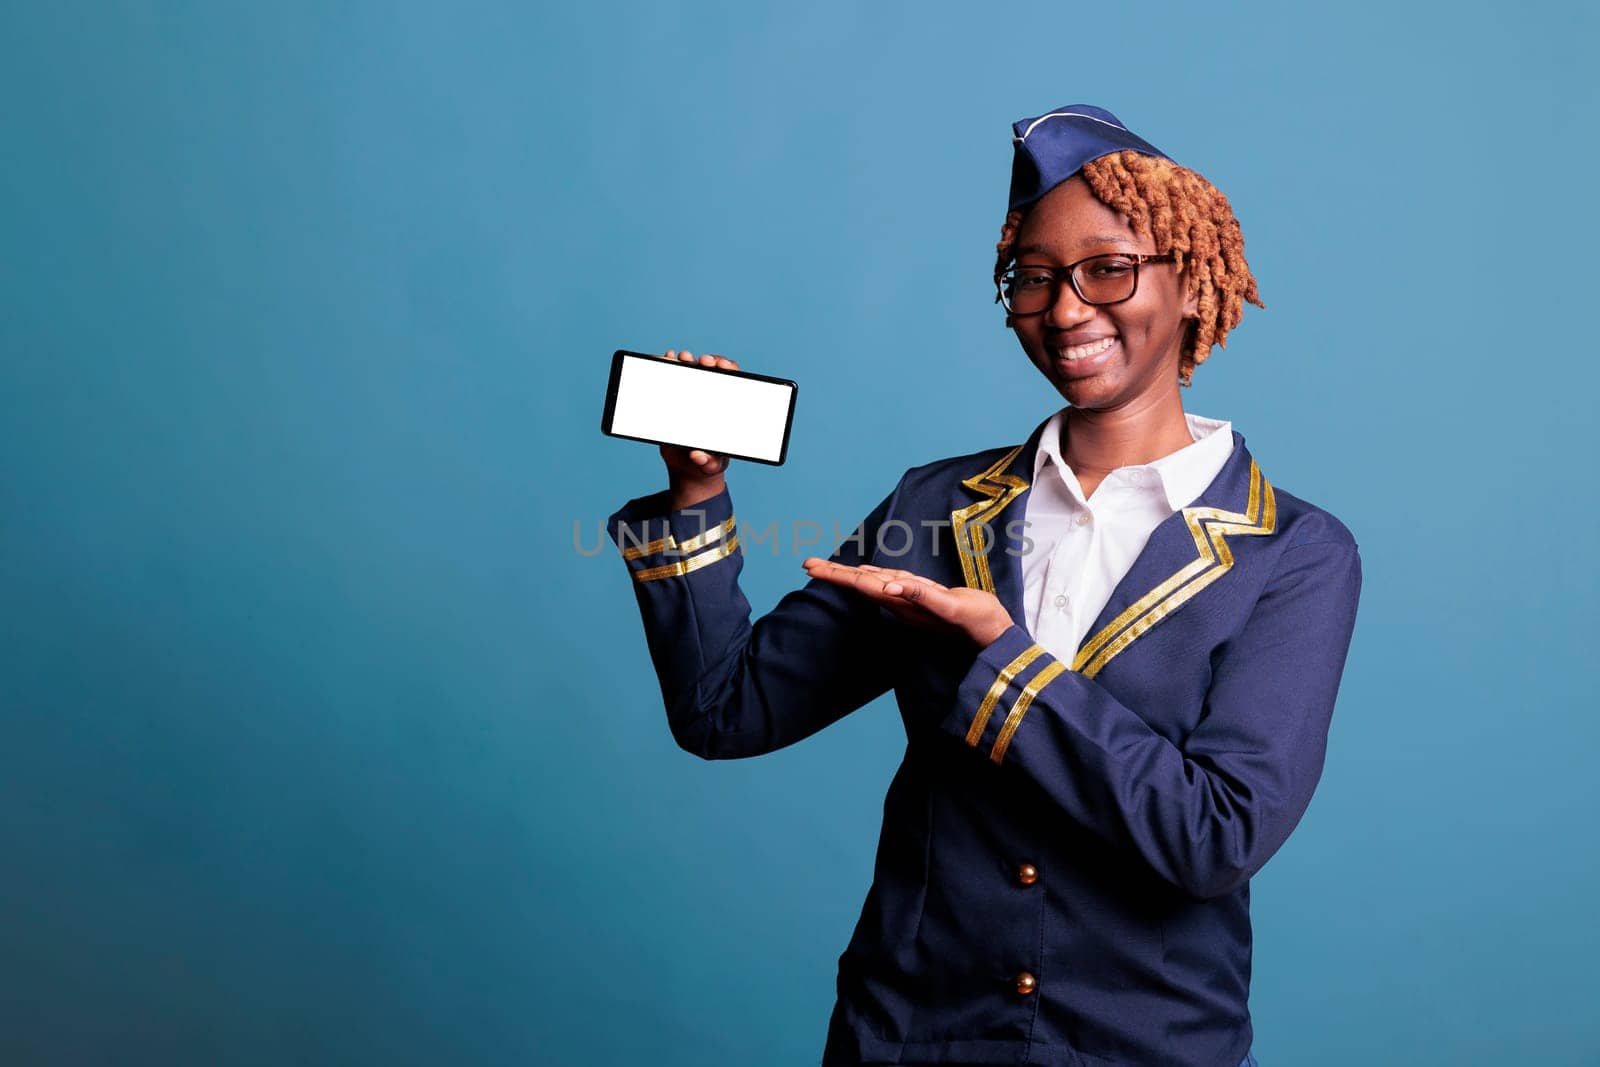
{"left": 1013, "top": 176, "right": 1197, "bottom": 411}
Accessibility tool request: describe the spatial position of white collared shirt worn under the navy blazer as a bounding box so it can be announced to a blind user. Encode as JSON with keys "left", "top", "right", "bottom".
{"left": 1022, "top": 408, "right": 1234, "bottom": 662}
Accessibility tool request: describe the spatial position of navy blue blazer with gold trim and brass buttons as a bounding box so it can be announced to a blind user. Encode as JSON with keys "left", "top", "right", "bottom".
{"left": 608, "top": 422, "right": 1362, "bottom": 1067}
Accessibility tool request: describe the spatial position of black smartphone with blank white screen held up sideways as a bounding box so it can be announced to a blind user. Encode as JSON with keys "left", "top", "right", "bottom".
{"left": 600, "top": 350, "right": 800, "bottom": 467}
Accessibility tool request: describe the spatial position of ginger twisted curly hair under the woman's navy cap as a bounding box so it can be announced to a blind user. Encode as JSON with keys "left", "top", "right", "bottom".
{"left": 995, "top": 152, "right": 1266, "bottom": 386}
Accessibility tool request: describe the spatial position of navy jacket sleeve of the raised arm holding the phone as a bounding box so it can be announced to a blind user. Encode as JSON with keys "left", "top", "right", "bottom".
{"left": 606, "top": 476, "right": 899, "bottom": 760}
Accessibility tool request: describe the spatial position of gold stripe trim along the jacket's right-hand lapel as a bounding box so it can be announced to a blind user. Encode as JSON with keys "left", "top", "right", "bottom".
{"left": 1072, "top": 459, "right": 1278, "bottom": 678}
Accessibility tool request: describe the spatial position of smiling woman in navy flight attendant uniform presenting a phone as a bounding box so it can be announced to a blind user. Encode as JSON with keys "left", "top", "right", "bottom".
{"left": 610, "top": 106, "right": 1362, "bottom": 1067}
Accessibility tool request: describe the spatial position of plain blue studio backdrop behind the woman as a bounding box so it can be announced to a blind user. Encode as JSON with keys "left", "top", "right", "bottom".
{"left": 0, "top": 2, "right": 1600, "bottom": 1067}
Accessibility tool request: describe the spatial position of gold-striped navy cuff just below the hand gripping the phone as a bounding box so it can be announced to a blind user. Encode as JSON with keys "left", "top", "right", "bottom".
{"left": 606, "top": 486, "right": 739, "bottom": 582}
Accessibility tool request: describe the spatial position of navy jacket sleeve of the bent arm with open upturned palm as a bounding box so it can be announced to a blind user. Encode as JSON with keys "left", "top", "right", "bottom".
{"left": 941, "top": 541, "right": 1362, "bottom": 897}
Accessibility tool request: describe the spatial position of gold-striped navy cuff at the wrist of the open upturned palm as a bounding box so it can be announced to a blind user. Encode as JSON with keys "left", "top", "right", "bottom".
{"left": 941, "top": 624, "right": 1067, "bottom": 763}
